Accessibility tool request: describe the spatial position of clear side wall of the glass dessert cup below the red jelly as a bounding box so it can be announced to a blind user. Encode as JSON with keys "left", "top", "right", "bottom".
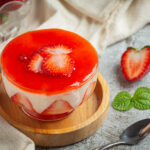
{"left": 1, "top": 67, "right": 97, "bottom": 121}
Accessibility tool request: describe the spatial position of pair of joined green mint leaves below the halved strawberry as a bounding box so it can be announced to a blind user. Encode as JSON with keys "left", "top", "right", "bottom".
{"left": 112, "top": 87, "right": 150, "bottom": 111}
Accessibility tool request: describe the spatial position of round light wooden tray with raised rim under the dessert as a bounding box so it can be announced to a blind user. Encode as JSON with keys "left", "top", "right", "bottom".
{"left": 0, "top": 73, "right": 109, "bottom": 147}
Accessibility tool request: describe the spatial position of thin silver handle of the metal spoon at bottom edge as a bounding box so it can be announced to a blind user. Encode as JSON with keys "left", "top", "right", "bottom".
{"left": 94, "top": 140, "right": 126, "bottom": 150}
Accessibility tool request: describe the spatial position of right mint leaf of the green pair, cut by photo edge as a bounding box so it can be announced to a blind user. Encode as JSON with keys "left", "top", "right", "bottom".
{"left": 132, "top": 87, "right": 150, "bottom": 110}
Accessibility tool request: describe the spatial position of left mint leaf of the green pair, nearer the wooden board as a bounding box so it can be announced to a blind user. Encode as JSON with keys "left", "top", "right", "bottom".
{"left": 112, "top": 91, "right": 133, "bottom": 111}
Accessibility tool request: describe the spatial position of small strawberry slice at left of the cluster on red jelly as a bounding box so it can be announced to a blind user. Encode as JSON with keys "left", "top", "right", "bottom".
{"left": 27, "top": 53, "right": 43, "bottom": 73}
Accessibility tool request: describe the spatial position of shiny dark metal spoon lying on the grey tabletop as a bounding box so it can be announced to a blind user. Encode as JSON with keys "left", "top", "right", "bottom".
{"left": 95, "top": 119, "right": 150, "bottom": 150}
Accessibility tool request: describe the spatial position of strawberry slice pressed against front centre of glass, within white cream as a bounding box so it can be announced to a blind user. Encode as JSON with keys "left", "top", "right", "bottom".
{"left": 42, "top": 100, "right": 73, "bottom": 115}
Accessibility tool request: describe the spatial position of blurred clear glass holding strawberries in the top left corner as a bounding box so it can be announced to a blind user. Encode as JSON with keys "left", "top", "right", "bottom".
{"left": 0, "top": 0, "right": 31, "bottom": 43}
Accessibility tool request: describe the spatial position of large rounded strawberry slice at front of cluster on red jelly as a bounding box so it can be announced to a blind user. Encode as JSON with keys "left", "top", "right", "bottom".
{"left": 42, "top": 54, "right": 73, "bottom": 77}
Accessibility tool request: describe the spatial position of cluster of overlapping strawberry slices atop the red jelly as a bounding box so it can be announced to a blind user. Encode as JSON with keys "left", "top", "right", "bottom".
{"left": 27, "top": 45, "right": 74, "bottom": 77}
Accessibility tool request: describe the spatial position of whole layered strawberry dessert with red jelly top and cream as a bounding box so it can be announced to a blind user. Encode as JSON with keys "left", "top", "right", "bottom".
{"left": 1, "top": 29, "right": 98, "bottom": 120}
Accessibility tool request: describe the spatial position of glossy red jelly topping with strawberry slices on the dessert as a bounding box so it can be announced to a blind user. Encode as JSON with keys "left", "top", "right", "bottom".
{"left": 1, "top": 29, "right": 98, "bottom": 95}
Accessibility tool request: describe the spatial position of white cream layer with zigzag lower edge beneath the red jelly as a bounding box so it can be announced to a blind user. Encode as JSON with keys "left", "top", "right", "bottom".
{"left": 2, "top": 73, "right": 97, "bottom": 114}
